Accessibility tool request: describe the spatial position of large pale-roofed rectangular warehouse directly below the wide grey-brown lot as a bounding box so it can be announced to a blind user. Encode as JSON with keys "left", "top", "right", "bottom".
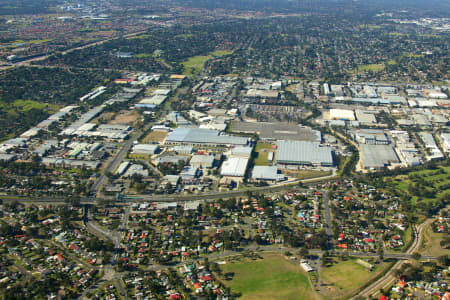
{"left": 277, "top": 141, "right": 334, "bottom": 167}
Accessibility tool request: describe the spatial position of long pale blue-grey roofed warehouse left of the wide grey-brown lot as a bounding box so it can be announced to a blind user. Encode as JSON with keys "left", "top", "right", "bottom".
{"left": 166, "top": 127, "right": 248, "bottom": 146}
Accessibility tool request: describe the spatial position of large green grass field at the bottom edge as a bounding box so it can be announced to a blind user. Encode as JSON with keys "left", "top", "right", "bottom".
{"left": 221, "top": 254, "right": 316, "bottom": 300}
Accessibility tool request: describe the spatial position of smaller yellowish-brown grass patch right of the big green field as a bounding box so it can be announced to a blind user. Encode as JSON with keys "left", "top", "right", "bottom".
{"left": 321, "top": 258, "right": 376, "bottom": 294}
